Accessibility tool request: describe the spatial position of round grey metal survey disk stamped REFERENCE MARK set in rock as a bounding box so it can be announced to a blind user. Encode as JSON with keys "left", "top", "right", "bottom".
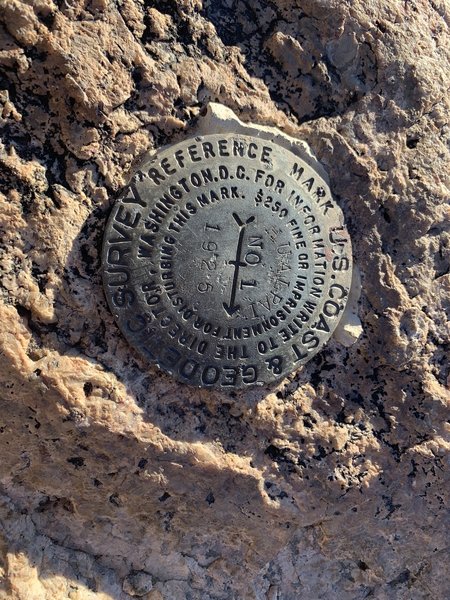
{"left": 103, "top": 133, "right": 352, "bottom": 390}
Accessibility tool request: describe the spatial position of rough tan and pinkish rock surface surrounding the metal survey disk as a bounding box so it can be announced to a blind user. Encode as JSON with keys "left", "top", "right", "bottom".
{"left": 0, "top": 0, "right": 450, "bottom": 600}
